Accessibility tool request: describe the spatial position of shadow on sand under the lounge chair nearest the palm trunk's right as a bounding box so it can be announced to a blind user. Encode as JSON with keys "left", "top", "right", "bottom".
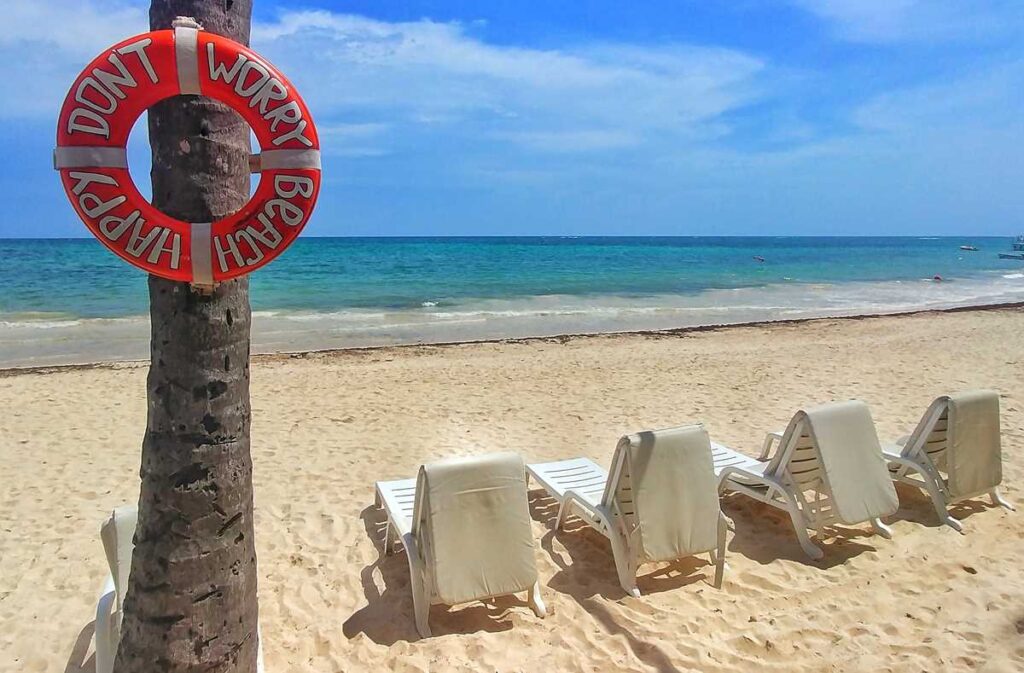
{"left": 342, "top": 505, "right": 529, "bottom": 645}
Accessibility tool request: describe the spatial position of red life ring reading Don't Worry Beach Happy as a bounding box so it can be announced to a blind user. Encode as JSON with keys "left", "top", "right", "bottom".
{"left": 53, "top": 24, "right": 321, "bottom": 286}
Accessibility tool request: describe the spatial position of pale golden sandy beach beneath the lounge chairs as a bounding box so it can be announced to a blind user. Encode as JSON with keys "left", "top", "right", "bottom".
{"left": 0, "top": 308, "right": 1024, "bottom": 673}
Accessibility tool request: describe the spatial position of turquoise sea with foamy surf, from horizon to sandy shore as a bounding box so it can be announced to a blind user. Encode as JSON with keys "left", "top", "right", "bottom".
{"left": 0, "top": 237, "right": 1024, "bottom": 366}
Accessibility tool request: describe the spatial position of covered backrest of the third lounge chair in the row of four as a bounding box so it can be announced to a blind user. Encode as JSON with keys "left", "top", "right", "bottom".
{"left": 788, "top": 399, "right": 899, "bottom": 524}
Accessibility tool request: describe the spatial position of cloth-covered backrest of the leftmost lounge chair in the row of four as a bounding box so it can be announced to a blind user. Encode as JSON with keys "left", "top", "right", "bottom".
{"left": 412, "top": 453, "right": 537, "bottom": 604}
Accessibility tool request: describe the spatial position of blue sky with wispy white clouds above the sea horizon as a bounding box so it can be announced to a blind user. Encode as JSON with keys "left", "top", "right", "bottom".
{"left": 0, "top": 0, "right": 1024, "bottom": 237}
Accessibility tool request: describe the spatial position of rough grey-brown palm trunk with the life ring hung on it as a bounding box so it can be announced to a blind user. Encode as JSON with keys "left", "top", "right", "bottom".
{"left": 114, "top": 0, "right": 258, "bottom": 673}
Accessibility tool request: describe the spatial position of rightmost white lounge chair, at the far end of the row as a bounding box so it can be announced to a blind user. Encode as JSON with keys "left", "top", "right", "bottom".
{"left": 882, "top": 390, "right": 1014, "bottom": 533}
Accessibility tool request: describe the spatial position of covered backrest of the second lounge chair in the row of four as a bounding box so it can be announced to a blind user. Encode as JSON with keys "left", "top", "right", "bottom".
{"left": 602, "top": 425, "right": 720, "bottom": 561}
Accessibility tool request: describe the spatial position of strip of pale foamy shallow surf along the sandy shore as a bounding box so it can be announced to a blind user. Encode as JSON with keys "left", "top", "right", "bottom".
{"left": 0, "top": 272, "right": 1024, "bottom": 367}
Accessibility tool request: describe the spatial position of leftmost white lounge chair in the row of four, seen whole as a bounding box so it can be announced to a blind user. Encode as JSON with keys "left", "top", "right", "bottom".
{"left": 376, "top": 453, "right": 547, "bottom": 637}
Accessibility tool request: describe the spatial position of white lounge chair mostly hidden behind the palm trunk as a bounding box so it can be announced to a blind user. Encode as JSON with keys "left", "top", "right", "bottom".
{"left": 93, "top": 505, "right": 263, "bottom": 673}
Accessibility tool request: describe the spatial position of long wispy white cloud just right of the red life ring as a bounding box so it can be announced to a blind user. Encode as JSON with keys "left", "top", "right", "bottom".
{"left": 253, "top": 11, "right": 765, "bottom": 152}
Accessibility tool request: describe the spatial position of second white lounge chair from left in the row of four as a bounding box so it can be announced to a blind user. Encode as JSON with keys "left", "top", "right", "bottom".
{"left": 526, "top": 425, "right": 727, "bottom": 596}
